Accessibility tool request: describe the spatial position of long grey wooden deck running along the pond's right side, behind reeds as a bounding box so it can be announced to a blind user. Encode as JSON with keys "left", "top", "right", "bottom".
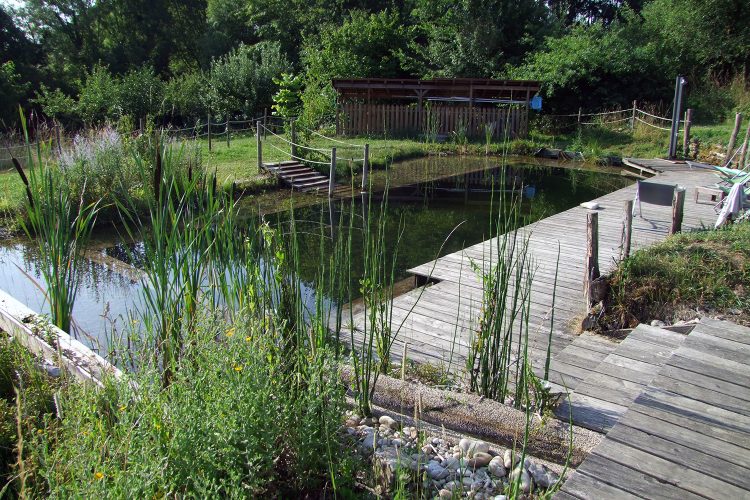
{"left": 345, "top": 160, "right": 728, "bottom": 431}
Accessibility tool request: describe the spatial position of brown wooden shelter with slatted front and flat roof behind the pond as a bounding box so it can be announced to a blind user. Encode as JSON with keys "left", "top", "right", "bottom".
{"left": 332, "top": 78, "right": 539, "bottom": 138}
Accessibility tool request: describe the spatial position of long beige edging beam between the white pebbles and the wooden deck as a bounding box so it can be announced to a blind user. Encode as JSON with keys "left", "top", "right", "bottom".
{"left": 341, "top": 367, "right": 604, "bottom": 467}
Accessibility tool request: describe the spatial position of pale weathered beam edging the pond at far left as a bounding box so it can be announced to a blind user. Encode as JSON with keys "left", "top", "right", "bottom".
{"left": 0, "top": 289, "right": 123, "bottom": 388}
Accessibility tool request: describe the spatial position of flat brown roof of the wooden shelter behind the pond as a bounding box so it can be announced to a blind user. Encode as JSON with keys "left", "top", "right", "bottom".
{"left": 332, "top": 78, "right": 539, "bottom": 101}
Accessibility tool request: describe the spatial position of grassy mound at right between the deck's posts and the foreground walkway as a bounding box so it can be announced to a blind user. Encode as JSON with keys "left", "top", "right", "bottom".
{"left": 603, "top": 221, "right": 750, "bottom": 329}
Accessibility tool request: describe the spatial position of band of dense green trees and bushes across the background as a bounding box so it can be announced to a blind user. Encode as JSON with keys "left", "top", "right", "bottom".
{"left": 0, "top": 0, "right": 750, "bottom": 126}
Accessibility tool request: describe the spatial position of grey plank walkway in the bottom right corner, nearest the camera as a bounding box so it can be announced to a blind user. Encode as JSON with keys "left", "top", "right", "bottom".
{"left": 555, "top": 319, "right": 750, "bottom": 500}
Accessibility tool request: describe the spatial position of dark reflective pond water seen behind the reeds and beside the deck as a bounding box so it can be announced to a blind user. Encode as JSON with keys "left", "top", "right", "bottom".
{"left": 0, "top": 158, "right": 629, "bottom": 349}
